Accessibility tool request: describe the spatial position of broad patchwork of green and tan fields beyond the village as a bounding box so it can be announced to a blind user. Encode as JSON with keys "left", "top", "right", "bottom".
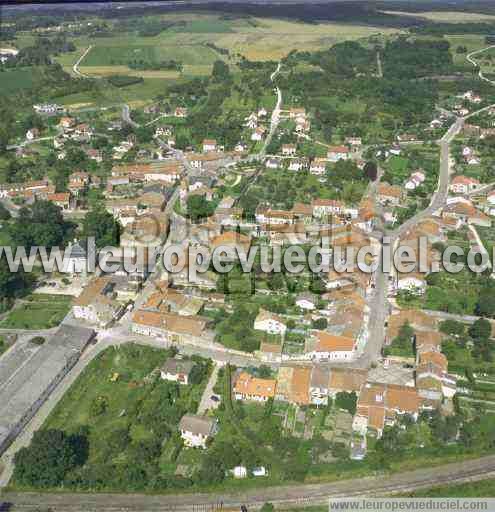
{"left": 57, "top": 14, "right": 396, "bottom": 79}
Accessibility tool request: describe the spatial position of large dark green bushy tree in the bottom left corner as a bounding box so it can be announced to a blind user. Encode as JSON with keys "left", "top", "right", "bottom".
{"left": 14, "top": 429, "right": 87, "bottom": 488}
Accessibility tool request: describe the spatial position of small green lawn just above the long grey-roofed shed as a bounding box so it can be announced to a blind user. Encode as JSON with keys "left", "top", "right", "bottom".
{"left": 0, "top": 294, "right": 72, "bottom": 329}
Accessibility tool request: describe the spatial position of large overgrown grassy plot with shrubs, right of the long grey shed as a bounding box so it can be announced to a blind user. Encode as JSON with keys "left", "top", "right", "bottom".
{"left": 32, "top": 343, "right": 209, "bottom": 491}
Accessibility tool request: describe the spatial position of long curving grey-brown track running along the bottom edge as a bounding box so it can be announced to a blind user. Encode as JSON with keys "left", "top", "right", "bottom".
{"left": 2, "top": 455, "right": 495, "bottom": 512}
